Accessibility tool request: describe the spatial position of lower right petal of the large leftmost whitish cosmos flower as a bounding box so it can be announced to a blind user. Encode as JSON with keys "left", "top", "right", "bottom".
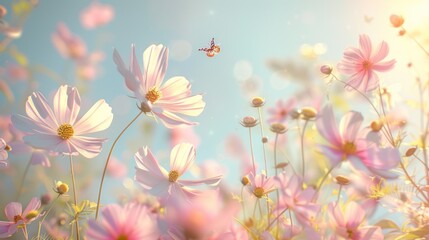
{"left": 69, "top": 136, "right": 106, "bottom": 158}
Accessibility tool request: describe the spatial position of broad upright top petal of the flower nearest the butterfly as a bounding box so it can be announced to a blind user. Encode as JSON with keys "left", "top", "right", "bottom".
{"left": 143, "top": 45, "right": 168, "bottom": 91}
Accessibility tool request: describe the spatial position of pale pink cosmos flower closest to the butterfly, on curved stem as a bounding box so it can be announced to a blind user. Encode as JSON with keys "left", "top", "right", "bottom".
{"left": 113, "top": 45, "right": 205, "bottom": 128}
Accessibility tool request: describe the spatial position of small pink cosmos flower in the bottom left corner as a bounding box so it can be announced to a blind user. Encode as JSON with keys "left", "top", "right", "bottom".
{"left": 0, "top": 198, "right": 40, "bottom": 238}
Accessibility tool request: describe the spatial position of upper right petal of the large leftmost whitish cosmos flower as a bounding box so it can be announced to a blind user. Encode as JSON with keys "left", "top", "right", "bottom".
{"left": 73, "top": 99, "right": 113, "bottom": 135}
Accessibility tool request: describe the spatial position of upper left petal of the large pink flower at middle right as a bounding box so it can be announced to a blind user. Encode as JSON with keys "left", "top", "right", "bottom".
{"left": 316, "top": 105, "right": 342, "bottom": 146}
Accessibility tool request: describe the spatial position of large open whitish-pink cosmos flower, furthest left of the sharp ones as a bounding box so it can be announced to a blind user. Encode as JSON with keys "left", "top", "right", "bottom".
{"left": 12, "top": 85, "right": 113, "bottom": 158}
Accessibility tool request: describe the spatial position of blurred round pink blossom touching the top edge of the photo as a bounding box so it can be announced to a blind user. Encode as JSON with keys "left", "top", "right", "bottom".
{"left": 80, "top": 2, "right": 115, "bottom": 29}
